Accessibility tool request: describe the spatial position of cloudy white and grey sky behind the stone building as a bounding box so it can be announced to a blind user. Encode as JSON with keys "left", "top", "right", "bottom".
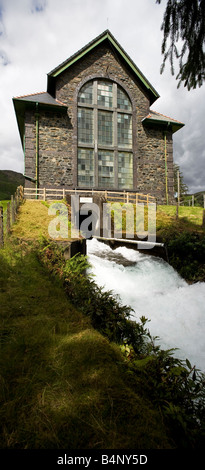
{"left": 0, "top": 0, "right": 205, "bottom": 192}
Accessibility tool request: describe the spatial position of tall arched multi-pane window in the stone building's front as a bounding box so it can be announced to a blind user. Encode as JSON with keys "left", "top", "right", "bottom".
{"left": 78, "top": 79, "right": 133, "bottom": 189}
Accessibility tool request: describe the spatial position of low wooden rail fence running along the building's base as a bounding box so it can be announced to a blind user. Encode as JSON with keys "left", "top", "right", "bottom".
{"left": 24, "top": 188, "right": 155, "bottom": 205}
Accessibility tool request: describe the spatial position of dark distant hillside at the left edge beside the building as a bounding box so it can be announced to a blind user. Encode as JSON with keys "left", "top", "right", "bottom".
{"left": 0, "top": 170, "right": 24, "bottom": 200}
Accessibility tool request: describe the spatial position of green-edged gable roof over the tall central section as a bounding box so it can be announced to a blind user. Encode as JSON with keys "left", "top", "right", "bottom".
{"left": 47, "top": 29, "right": 160, "bottom": 104}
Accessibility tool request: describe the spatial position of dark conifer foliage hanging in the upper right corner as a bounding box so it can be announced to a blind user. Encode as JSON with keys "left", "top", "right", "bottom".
{"left": 156, "top": 0, "right": 205, "bottom": 90}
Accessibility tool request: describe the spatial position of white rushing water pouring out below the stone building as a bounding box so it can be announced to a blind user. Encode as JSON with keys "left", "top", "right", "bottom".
{"left": 87, "top": 239, "right": 205, "bottom": 372}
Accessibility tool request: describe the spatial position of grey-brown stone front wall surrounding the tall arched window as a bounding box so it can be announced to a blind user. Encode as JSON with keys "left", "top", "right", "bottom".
{"left": 25, "top": 44, "right": 173, "bottom": 203}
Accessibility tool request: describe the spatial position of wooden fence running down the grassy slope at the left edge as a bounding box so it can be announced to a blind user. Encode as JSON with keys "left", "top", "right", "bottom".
{"left": 0, "top": 186, "right": 24, "bottom": 247}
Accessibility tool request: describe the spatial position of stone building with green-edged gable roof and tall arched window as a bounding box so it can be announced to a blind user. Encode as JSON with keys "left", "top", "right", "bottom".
{"left": 13, "top": 30, "right": 184, "bottom": 203}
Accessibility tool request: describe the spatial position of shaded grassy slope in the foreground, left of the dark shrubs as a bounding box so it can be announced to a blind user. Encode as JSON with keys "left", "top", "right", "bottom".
{"left": 0, "top": 240, "right": 171, "bottom": 449}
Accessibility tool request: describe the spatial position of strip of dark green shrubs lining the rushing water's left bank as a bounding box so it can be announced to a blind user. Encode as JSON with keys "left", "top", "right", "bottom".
{"left": 38, "top": 241, "right": 205, "bottom": 448}
